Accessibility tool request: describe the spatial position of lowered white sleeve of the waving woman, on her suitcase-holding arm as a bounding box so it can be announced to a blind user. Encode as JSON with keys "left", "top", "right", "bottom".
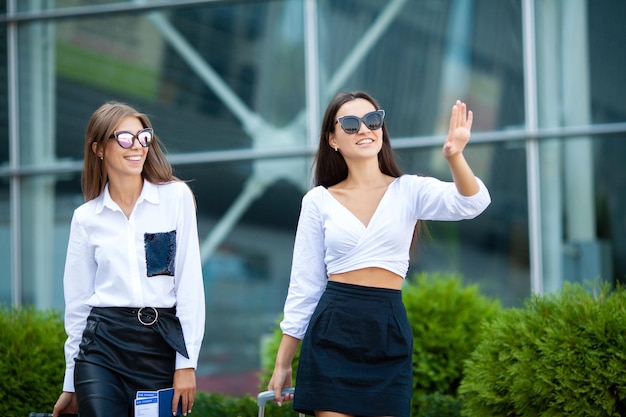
{"left": 280, "top": 193, "right": 327, "bottom": 339}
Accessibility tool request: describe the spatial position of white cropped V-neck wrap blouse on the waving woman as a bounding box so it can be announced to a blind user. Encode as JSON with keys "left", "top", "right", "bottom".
{"left": 281, "top": 175, "right": 491, "bottom": 339}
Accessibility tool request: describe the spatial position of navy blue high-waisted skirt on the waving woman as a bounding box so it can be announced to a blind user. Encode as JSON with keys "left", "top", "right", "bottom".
{"left": 293, "top": 281, "right": 413, "bottom": 417}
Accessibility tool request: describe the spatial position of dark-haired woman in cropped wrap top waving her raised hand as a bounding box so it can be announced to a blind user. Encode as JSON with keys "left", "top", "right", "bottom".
{"left": 268, "top": 92, "right": 491, "bottom": 417}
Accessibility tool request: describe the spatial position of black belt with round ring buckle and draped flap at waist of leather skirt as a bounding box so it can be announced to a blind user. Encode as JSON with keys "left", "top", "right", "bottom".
{"left": 91, "top": 307, "right": 189, "bottom": 359}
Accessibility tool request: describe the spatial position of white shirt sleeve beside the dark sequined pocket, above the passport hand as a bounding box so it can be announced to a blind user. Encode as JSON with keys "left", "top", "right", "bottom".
{"left": 174, "top": 183, "right": 206, "bottom": 369}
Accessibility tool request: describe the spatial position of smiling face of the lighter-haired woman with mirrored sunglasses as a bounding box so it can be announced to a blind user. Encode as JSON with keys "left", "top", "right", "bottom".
{"left": 93, "top": 117, "right": 150, "bottom": 180}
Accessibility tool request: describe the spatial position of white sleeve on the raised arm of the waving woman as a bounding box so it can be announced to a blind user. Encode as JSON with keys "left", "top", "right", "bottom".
{"left": 407, "top": 175, "right": 491, "bottom": 220}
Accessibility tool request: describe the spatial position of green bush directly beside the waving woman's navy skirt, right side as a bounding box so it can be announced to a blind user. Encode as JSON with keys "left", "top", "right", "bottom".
{"left": 402, "top": 273, "right": 502, "bottom": 417}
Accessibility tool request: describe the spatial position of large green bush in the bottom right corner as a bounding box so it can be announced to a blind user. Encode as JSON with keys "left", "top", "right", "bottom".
{"left": 459, "top": 283, "right": 626, "bottom": 417}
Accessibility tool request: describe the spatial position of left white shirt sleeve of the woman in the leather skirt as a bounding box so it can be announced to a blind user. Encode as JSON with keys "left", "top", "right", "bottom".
{"left": 63, "top": 211, "right": 97, "bottom": 392}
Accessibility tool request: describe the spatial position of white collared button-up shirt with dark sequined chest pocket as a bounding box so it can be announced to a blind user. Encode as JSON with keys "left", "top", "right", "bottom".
{"left": 63, "top": 181, "right": 206, "bottom": 392}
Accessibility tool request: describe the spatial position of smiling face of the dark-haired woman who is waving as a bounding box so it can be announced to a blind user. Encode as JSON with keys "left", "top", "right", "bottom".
{"left": 328, "top": 98, "right": 383, "bottom": 159}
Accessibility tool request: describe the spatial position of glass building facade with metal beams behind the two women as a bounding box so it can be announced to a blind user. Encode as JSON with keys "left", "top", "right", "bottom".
{"left": 0, "top": 0, "right": 626, "bottom": 393}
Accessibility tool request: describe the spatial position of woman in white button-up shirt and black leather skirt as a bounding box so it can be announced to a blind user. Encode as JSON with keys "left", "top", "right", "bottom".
{"left": 53, "top": 102, "right": 205, "bottom": 417}
